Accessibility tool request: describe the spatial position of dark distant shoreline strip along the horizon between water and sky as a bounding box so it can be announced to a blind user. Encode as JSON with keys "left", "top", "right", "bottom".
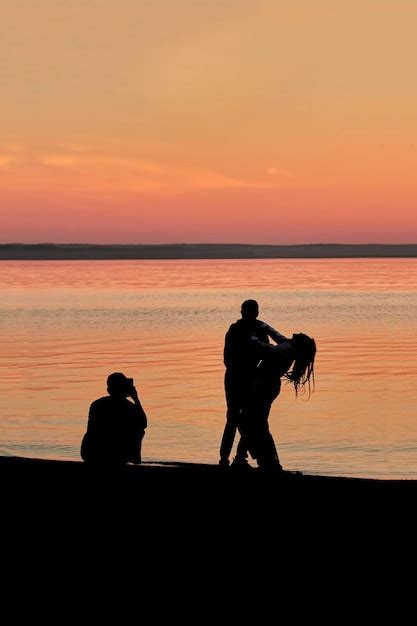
{"left": 0, "top": 243, "right": 417, "bottom": 261}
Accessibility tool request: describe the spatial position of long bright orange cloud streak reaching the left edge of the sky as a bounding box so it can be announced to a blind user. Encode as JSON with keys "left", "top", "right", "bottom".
{"left": 0, "top": 141, "right": 288, "bottom": 195}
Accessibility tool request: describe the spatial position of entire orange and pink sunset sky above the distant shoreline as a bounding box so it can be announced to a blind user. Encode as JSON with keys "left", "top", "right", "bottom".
{"left": 0, "top": 0, "right": 417, "bottom": 244}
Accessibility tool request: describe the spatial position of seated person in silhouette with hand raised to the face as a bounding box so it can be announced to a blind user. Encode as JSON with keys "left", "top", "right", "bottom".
{"left": 81, "top": 372, "right": 147, "bottom": 466}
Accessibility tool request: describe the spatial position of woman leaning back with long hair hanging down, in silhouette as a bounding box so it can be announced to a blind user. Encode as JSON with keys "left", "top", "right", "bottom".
{"left": 239, "top": 333, "right": 316, "bottom": 470}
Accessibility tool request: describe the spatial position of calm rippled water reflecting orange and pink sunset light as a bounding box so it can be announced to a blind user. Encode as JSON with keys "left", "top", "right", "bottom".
{"left": 0, "top": 259, "right": 417, "bottom": 478}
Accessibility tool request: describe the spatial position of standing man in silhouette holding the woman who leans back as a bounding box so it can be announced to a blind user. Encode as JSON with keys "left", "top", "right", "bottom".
{"left": 219, "top": 300, "right": 285, "bottom": 467}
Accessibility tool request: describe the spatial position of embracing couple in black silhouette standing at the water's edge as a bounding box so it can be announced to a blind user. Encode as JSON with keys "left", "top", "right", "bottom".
{"left": 219, "top": 300, "right": 316, "bottom": 472}
